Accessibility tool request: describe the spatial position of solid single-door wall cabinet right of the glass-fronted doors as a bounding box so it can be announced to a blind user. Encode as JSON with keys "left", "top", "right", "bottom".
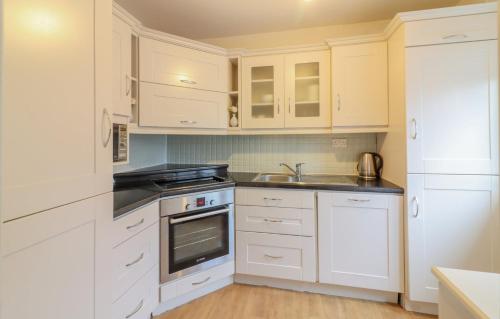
{"left": 332, "top": 42, "right": 389, "bottom": 127}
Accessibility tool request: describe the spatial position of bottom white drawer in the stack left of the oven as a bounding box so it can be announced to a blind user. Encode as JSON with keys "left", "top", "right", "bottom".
{"left": 112, "top": 267, "right": 160, "bottom": 319}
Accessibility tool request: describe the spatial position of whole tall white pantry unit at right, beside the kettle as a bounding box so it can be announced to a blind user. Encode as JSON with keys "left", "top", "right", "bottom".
{"left": 379, "top": 4, "right": 500, "bottom": 309}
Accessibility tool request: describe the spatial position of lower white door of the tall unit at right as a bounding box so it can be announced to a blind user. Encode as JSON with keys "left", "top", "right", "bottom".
{"left": 407, "top": 175, "right": 500, "bottom": 303}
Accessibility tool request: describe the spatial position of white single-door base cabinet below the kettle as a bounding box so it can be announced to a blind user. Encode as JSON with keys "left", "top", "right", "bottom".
{"left": 318, "top": 192, "right": 404, "bottom": 292}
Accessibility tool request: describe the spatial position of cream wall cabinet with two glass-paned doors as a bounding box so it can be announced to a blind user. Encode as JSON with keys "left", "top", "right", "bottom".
{"left": 242, "top": 51, "right": 331, "bottom": 129}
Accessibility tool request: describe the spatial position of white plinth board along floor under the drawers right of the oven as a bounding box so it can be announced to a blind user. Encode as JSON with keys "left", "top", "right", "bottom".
{"left": 234, "top": 274, "right": 398, "bottom": 303}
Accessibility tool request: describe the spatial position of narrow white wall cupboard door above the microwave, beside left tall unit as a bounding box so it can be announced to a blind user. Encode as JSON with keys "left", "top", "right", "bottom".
{"left": 113, "top": 16, "right": 132, "bottom": 117}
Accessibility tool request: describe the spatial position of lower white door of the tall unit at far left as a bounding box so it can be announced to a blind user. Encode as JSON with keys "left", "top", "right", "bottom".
{"left": 0, "top": 193, "right": 113, "bottom": 319}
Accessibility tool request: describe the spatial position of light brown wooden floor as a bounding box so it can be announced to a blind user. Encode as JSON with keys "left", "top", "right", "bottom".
{"left": 155, "top": 284, "right": 436, "bottom": 319}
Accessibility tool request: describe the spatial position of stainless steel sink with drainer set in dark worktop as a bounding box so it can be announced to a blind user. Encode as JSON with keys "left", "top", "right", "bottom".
{"left": 253, "top": 173, "right": 358, "bottom": 186}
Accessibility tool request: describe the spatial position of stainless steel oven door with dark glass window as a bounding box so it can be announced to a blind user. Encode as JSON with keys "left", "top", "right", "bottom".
{"left": 160, "top": 204, "right": 234, "bottom": 284}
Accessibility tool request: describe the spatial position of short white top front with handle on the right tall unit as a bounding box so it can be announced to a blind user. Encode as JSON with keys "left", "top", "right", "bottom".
{"left": 405, "top": 13, "right": 498, "bottom": 46}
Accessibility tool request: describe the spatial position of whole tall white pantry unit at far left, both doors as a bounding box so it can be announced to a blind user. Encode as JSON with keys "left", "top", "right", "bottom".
{"left": 0, "top": 0, "right": 113, "bottom": 319}
